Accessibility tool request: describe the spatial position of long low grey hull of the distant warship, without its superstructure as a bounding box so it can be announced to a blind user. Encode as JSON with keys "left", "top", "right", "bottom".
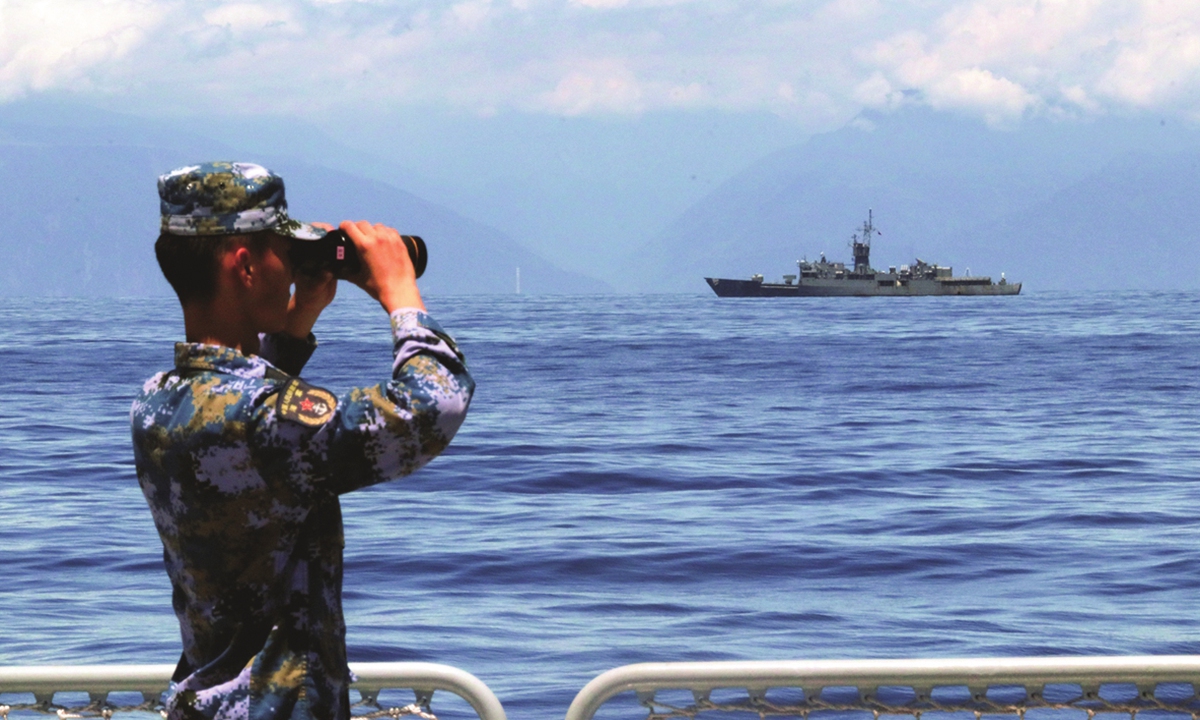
{"left": 704, "top": 277, "right": 1021, "bottom": 298}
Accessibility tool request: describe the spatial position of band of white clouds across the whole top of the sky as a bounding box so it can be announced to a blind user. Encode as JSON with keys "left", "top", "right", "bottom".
{"left": 7, "top": 0, "right": 1200, "bottom": 130}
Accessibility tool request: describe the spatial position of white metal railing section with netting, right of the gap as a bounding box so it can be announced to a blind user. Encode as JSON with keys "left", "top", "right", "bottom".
{"left": 566, "top": 655, "right": 1200, "bottom": 720}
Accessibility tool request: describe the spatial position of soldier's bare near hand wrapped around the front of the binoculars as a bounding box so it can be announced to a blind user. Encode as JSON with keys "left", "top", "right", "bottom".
{"left": 341, "top": 221, "right": 425, "bottom": 312}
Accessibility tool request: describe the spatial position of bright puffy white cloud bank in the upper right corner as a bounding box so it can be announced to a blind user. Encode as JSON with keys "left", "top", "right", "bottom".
{"left": 868, "top": 0, "right": 1200, "bottom": 121}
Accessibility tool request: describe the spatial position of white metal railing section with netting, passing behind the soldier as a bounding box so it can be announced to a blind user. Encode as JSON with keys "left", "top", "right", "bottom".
{"left": 0, "top": 662, "right": 506, "bottom": 720}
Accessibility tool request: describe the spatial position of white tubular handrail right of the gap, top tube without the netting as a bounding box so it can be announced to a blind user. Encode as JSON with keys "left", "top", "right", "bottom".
{"left": 566, "top": 655, "right": 1200, "bottom": 720}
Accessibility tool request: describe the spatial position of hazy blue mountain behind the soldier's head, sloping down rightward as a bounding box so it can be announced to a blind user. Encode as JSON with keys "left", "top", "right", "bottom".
{"left": 0, "top": 107, "right": 611, "bottom": 296}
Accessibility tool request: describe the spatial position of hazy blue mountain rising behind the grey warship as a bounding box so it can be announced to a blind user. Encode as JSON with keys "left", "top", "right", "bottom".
{"left": 625, "top": 110, "right": 1200, "bottom": 292}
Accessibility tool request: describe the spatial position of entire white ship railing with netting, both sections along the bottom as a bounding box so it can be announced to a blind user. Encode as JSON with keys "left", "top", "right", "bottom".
{"left": 7, "top": 655, "right": 1200, "bottom": 720}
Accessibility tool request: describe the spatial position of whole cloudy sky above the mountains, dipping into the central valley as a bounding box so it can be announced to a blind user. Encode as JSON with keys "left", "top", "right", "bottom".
{"left": 0, "top": 0, "right": 1200, "bottom": 280}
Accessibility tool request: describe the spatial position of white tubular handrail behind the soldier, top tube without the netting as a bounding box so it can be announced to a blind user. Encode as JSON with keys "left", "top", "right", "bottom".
{"left": 0, "top": 662, "right": 506, "bottom": 720}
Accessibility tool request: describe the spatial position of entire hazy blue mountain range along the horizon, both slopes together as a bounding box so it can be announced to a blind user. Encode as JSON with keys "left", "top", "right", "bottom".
{"left": 0, "top": 103, "right": 1200, "bottom": 296}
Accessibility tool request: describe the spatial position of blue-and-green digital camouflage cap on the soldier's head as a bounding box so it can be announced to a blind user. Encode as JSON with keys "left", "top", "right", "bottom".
{"left": 158, "top": 162, "right": 325, "bottom": 240}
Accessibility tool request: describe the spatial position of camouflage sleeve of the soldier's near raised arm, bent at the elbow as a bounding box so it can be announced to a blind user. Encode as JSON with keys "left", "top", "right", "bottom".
{"left": 313, "top": 308, "right": 475, "bottom": 493}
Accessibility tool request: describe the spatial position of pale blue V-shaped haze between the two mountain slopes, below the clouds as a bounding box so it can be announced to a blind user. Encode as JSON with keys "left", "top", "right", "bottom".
{"left": 159, "top": 108, "right": 808, "bottom": 280}
